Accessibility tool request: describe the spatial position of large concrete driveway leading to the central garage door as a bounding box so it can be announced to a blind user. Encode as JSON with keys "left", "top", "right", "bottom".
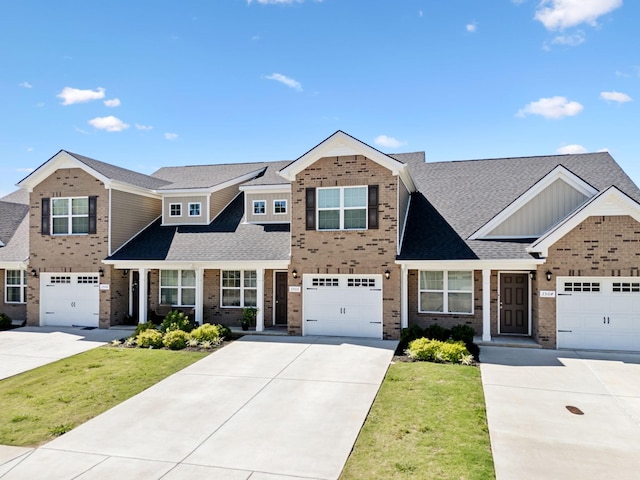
{"left": 0, "top": 336, "right": 397, "bottom": 480}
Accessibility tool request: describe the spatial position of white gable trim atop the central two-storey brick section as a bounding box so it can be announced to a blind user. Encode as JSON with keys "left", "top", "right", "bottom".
{"left": 278, "top": 130, "right": 416, "bottom": 193}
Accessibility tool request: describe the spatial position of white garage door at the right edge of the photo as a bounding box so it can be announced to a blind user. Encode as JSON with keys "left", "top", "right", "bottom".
{"left": 556, "top": 277, "right": 640, "bottom": 351}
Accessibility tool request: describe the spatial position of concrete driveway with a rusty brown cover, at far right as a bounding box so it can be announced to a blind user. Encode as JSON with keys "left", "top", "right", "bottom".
{"left": 480, "top": 347, "right": 640, "bottom": 480}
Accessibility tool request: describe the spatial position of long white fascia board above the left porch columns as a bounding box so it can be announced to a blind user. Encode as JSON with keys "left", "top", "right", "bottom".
{"left": 102, "top": 260, "right": 290, "bottom": 270}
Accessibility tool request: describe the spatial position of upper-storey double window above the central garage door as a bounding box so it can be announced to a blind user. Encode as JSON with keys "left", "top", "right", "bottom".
{"left": 318, "top": 187, "right": 367, "bottom": 230}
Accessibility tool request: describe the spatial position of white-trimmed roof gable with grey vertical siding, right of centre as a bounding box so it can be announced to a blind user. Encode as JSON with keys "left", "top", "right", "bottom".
{"left": 469, "top": 165, "right": 598, "bottom": 240}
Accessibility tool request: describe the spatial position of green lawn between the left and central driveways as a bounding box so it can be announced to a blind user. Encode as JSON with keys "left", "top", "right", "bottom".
{"left": 0, "top": 347, "right": 209, "bottom": 446}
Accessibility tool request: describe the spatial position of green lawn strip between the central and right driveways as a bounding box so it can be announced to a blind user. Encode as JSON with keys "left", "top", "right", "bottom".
{"left": 340, "top": 362, "right": 495, "bottom": 480}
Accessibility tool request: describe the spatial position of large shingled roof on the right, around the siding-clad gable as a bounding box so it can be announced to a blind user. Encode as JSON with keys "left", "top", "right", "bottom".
{"left": 398, "top": 152, "right": 640, "bottom": 260}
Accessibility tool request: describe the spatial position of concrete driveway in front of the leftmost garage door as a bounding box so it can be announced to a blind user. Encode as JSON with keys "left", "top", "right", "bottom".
{"left": 0, "top": 327, "right": 131, "bottom": 380}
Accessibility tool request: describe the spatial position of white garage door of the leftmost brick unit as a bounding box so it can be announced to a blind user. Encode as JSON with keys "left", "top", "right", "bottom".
{"left": 40, "top": 273, "right": 100, "bottom": 327}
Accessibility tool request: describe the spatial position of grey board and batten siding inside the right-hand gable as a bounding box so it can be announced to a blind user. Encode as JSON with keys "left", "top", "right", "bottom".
{"left": 487, "top": 180, "right": 588, "bottom": 238}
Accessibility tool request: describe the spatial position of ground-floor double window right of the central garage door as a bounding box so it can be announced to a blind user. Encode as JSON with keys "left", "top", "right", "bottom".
{"left": 419, "top": 270, "right": 473, "bottom": 313}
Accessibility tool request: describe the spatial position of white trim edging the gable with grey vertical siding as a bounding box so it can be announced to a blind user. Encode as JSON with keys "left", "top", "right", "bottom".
{"left": 469, "top": 165, "right": 598, "bottom": 240}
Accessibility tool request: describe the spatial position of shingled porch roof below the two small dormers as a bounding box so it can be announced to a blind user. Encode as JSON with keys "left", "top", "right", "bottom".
{"left": 107, "top": 193, "right": 290, "bottom": 262}
